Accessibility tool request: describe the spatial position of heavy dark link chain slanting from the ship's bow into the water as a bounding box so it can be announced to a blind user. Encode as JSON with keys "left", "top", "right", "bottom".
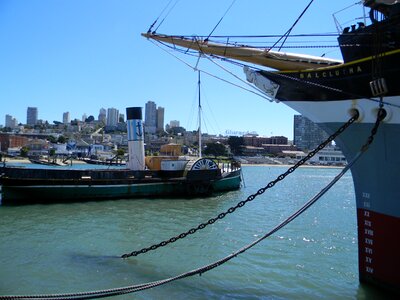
{"left": 121, "top": 108, "right": 360, "bottom": 258}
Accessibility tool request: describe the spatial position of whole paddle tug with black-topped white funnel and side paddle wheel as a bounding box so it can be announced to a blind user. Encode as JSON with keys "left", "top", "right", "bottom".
{"left": 0, "top": 107, "right": 241, "bottom": 204}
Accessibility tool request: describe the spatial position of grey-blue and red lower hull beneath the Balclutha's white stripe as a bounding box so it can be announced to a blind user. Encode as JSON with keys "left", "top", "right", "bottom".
{"left": 320, "top": 123, "right": 400, "bottom": 292}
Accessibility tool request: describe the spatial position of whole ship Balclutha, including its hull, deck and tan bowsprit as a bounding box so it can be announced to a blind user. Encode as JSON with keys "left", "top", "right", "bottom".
{"left": 142, "top": 0, "right": 400, "bottom": 292}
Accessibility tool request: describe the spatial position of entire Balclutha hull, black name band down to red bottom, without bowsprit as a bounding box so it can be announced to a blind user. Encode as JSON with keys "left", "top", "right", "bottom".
{"left": 245, "top": 51, "right": 400, "bottom": 293}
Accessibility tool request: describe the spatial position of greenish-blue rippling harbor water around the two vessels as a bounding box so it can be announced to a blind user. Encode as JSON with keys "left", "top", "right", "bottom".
{"left": 0, "top": 166, "right": 390, "bottom": 299}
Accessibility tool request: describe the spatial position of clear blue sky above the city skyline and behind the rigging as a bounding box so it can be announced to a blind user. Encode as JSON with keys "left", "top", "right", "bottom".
{"left": 0, "top": 0, "right": 362, "bottom": 139}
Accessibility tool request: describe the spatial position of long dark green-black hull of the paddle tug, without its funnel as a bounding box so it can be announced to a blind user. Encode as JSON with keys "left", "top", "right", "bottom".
{"left": 0, "top": 167, "right": 241, "bottom": 204}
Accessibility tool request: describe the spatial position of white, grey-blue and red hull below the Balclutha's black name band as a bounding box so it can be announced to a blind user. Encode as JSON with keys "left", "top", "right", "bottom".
{"left": 284, "top": 96, "right": 400, "bottom": 293}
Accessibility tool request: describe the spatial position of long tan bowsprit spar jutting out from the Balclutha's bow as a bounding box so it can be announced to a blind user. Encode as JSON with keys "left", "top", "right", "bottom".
{"left": 142, "top": 32, "right": 343, "bottom": 71}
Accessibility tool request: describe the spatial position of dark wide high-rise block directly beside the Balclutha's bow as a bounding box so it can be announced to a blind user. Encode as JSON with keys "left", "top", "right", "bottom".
{"left": 293, "top": 115, "right": 329, "bottom": 150}
